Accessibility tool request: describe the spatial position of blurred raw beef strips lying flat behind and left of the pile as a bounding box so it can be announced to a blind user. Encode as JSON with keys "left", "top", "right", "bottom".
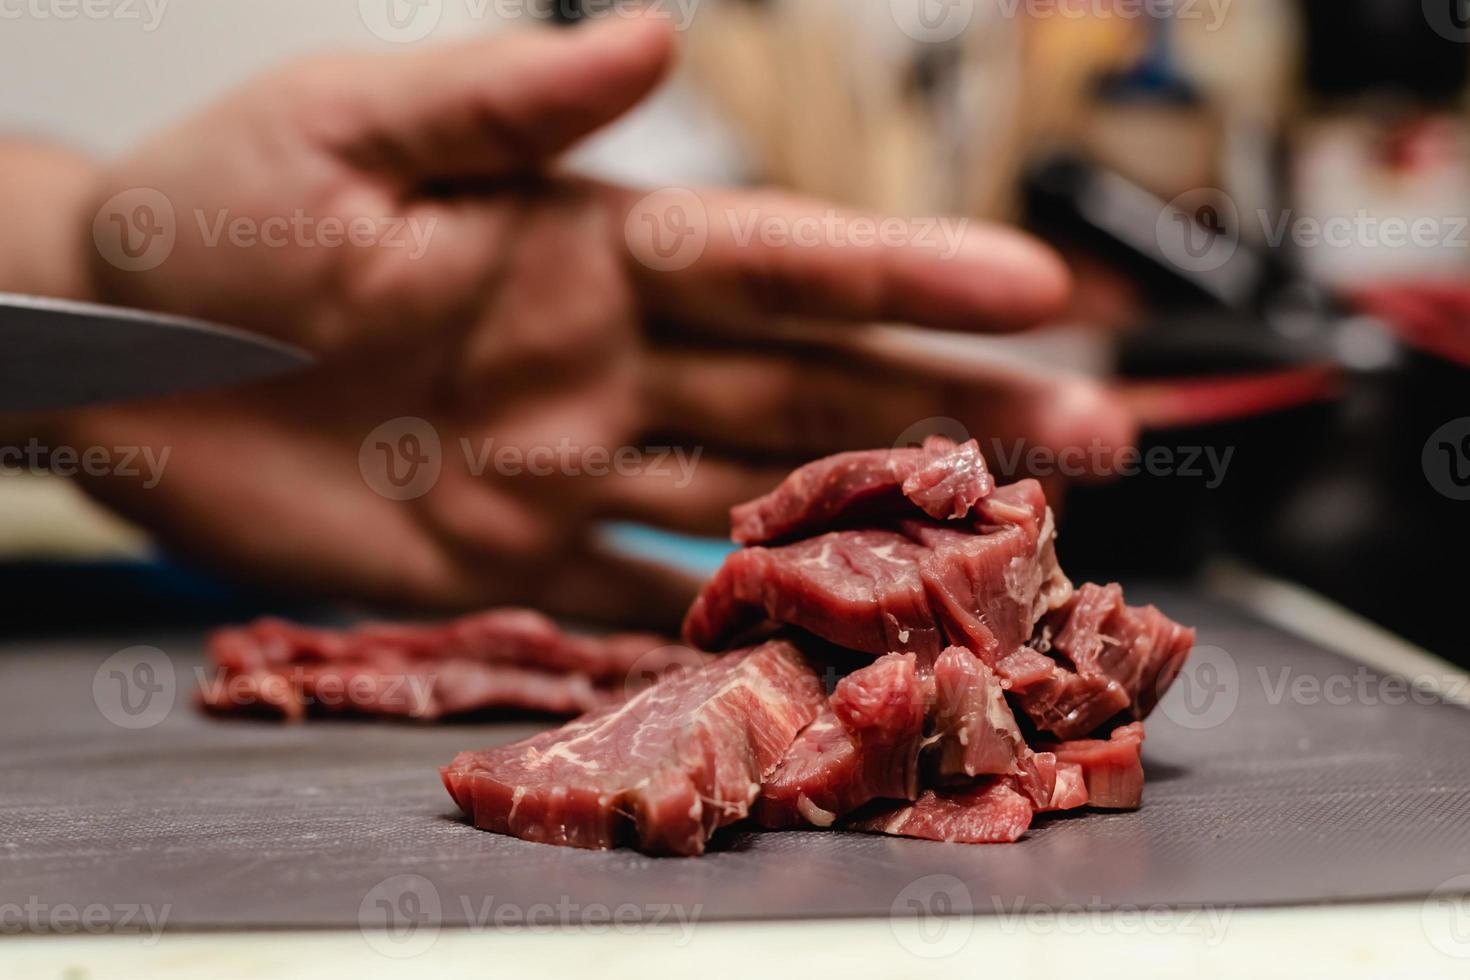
{"left": 200, "top": 610, "right": 707, "bottom": 720}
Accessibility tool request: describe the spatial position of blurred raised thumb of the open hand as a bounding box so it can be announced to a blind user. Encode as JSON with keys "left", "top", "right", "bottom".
{"left": 316, "top": 16, "right": 673, "bottom": 181}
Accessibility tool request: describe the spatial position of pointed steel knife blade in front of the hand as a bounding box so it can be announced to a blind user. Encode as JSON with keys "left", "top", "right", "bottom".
{"left": 0, "top": 294, "right": 312, "bottom": 411}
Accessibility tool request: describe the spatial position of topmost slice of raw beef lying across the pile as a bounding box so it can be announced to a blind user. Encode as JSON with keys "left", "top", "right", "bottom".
{"left": 731, "top": 436, "right": 995, "bottom": 545}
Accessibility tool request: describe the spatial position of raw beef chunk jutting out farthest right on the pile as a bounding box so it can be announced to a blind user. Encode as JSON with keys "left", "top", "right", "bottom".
{"left": 997, "top": 585, "right": 1195, "bottom": 739}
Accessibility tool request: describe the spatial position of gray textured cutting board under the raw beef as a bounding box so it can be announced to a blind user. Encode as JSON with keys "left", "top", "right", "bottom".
{"left": 0, "top": 589, "right": 1470, "bottom": 929}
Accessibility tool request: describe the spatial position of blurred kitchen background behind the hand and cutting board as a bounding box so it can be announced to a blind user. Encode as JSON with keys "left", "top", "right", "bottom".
{"left": 0, "top": 0, "right": 1470, "bottom": 663}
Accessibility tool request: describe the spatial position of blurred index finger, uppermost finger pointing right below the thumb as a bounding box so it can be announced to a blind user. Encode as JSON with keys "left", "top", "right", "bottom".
{"left": 614, "top": 191, "right": 1070, "bottom": 331}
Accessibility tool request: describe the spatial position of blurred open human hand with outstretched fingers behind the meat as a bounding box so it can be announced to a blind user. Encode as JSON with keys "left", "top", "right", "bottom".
{"left": 68, "top": 13, "right": 1132, "bottom": 623}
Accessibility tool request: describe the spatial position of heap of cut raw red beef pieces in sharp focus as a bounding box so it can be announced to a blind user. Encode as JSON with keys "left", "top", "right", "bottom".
{"left": 442, "top": 441, "right": 1194, "bottom": 855}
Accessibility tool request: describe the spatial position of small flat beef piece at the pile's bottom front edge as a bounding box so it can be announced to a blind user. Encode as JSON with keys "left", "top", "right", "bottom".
{"left": 844, "top": 776, "right": 1035, "bottom": 843}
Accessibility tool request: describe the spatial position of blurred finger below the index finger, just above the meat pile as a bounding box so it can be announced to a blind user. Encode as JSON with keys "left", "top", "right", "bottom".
{"left": 645, "top": 350, "right": 1135, "bottom": 479}
